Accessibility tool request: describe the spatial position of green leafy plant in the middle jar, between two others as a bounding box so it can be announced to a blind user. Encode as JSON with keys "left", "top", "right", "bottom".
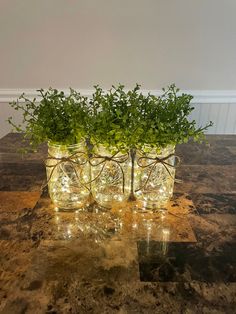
{"left": 90, "top": 85, "right": 145, "bottom": 151}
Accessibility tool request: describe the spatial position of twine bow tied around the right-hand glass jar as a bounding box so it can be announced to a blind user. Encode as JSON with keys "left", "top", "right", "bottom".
{"left": 135, "top": 153, "right": 180, "bottom": 192}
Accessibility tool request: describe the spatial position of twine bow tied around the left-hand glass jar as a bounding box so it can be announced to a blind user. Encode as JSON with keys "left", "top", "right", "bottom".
{"left": 42, "top": 151, "right": 87, "bottom": 189}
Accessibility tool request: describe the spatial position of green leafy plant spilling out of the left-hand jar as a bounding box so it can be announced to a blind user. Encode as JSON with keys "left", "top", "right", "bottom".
{"left": 8, "top": 88, "right": 89, "bottom": 148}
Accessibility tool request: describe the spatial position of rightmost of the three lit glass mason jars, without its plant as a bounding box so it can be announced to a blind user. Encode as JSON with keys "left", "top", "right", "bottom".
{"left": 135, "top": 145, "right": 175, "bottom": 209}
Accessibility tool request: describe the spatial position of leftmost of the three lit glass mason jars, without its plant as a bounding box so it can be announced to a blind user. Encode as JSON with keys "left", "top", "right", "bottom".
{"left": 46, "top": 143, "right": 90, "bottom": 210}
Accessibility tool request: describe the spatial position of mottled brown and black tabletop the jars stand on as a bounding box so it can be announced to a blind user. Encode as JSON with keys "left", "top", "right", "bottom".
{"left": 0, "top": 134, "right": 236, "bottom": 314}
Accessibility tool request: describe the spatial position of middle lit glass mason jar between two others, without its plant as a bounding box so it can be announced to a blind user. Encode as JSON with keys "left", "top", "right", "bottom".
{"left": 90, "top": 145, "right": 130, "bottom": 208}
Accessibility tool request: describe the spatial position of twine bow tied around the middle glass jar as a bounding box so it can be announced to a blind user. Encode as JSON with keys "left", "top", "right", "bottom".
{"left": 89, "top": 152, "right": 129, "bottom": 193}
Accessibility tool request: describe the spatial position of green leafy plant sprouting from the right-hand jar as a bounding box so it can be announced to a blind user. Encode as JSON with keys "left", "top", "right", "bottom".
{"left": 141, "top": 84, "right": 212, "bottom": 151}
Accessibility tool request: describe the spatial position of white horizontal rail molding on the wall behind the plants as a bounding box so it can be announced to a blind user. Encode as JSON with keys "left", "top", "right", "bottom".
{"left": 0, "top": 88, "right": 236, "bottom": 104}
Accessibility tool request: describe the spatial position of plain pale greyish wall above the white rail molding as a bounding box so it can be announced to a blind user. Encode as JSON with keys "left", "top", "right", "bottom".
{"left": 0, "top": 0, "right": 236, "bottom": 90}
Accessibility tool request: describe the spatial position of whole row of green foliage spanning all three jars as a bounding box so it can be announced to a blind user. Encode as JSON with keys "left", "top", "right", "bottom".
{"left": 9, "top": 84, "right": 212, "bottom": 152}
